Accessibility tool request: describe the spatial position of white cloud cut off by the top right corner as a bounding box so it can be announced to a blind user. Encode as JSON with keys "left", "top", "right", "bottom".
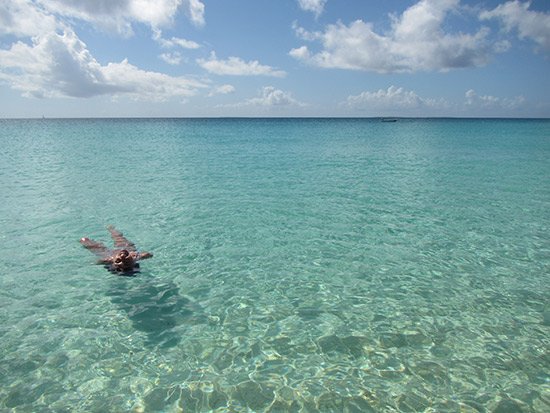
{"left": 480, "top": 0, "right": 550, "bottom": 51}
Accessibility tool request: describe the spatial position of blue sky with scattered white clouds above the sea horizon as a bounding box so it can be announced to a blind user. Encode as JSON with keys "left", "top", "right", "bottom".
{"left": 0, "top": 0, "right": 550, "bottom": 118}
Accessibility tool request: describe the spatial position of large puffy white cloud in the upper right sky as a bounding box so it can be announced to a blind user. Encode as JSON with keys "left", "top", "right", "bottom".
{"left": 289, "top": 0, "right": 497, "bottom": 73}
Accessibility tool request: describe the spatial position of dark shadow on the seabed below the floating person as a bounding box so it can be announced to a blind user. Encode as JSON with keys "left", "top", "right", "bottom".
{"left": 107, "top": 277, "right": 204, "bottom": 348}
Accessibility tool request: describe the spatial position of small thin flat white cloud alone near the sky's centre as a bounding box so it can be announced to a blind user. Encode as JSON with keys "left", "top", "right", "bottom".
{"left": 197, "top": 52, "right": 286, "bottom": 77}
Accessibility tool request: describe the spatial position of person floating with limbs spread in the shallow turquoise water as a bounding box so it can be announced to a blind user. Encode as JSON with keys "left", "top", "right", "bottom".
{"left": 80, "top": 225, "right": 153, "bottom": 275}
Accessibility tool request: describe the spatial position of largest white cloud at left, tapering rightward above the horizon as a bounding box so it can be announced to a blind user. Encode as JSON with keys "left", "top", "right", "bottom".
{"left": 0, "top": 29, "right": 206, "bottom": 101}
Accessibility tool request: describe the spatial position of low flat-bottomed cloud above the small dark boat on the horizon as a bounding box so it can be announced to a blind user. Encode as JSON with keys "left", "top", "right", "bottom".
{"left": 345, "top": 85, "right": 446, "bottom": 111}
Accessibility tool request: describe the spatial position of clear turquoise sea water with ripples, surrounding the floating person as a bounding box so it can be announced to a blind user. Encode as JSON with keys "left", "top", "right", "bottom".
{"left": 0, "top": 119, "right": 550, "bottom": 413}
